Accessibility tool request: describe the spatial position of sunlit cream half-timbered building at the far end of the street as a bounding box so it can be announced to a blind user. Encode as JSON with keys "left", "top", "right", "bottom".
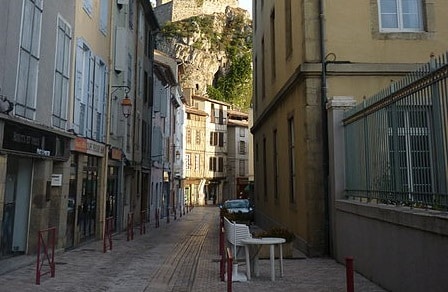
{"left": 183, "top": 89, "right": 229, "bottom": 206}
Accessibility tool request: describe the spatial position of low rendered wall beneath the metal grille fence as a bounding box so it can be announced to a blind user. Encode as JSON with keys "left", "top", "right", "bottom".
{"left": 333, "top": 200, "right": 448, "bottom": 292}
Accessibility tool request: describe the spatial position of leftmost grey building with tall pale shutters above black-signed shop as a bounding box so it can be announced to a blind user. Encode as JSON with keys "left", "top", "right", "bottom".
{"left": 0, "top": 0, "right": 75, "bottom": 258}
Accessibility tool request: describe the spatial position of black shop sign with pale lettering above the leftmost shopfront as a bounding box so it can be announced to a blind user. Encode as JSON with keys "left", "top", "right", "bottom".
{"left": 2, "top": 122, "right": 68, "bottom": 158}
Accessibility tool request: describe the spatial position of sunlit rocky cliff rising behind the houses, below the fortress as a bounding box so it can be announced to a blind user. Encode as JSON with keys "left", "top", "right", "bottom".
{"left": 157, "top": 6, "right": 252, "bottom": 96}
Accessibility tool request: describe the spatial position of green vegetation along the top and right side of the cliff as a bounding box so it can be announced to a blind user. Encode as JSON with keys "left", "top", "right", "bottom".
{"left": 161, "top": 13, "right": 252, "bottom": 110}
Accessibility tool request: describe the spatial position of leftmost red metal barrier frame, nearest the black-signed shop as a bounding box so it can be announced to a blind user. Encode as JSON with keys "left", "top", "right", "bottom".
{"left": 36, "top": 227, "right": 56, "bottom": 285}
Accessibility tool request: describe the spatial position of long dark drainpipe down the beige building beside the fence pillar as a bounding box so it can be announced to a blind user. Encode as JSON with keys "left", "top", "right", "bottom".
{"left": 319, "top": 0, "right": 333, "bottom": 256}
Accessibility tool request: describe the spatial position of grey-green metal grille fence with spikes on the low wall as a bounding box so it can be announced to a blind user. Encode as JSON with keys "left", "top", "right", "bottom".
{"left": 343, "top": 53, "right": 448, "bottom": 210}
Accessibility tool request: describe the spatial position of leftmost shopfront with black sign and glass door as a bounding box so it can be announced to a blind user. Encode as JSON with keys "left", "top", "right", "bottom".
{"left": 0, "top": 120, "right": 71, "bottom": 258}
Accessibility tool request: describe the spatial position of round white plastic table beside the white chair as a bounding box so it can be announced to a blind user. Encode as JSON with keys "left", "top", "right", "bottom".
{"left": 241, "top": 237, "right": 286, "bottom": 281}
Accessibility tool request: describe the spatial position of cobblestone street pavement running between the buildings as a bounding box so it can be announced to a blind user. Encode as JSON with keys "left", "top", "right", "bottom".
{"left": 0, "top": 207, "right": 384, "bottom": 292}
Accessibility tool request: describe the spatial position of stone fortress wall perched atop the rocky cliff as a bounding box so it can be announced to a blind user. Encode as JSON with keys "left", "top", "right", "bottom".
{"left": 154, "top": 0, "right": 238, "bottom": 25}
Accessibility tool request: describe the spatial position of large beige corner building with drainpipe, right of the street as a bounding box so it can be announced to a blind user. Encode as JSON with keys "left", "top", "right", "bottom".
{"left": 251, "top": 0, "right": 448, "bottom": 256}
